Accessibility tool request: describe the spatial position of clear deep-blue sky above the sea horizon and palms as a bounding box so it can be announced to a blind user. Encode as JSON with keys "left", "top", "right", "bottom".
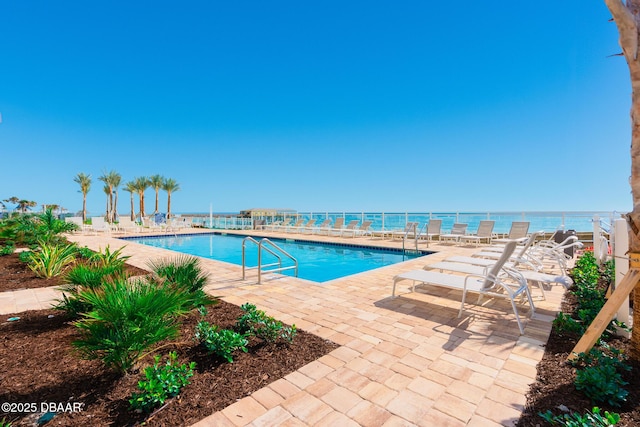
{"left": 0, "top": 0, "right": 632, "bottom": 215}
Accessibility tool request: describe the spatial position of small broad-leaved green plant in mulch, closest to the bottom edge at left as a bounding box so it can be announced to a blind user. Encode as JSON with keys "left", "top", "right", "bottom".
{"left": 129, "top": 352, "right": 196, "bottom": 412}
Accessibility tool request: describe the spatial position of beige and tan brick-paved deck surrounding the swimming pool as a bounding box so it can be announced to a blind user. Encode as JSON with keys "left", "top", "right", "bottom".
{"left": 0, "top": 229, "right": 564, "bottom": 427}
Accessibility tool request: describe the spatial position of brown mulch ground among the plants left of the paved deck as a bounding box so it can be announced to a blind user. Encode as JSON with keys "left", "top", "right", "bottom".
{"left": 0, "top": 255, "right": 338, "bottom": 427}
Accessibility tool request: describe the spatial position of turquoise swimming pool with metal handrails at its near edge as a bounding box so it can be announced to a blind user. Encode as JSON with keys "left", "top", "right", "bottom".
{"left": 125, "top": 233, "right": 432, "bottom": 282}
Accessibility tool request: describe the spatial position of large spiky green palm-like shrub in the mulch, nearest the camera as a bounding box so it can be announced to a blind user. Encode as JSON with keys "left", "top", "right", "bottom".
{"left": 73, "top": 279, "right": 188, "bottom": 373}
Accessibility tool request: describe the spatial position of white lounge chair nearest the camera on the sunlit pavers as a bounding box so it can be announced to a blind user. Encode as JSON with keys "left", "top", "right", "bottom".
{"left": 392, "top": 241, "right": 535, "bottom": 334}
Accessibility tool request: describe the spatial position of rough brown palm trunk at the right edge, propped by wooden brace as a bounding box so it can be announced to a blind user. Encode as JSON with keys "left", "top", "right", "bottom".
{"left": 605, "top": 0, "right": 640, "bottom": 361}
